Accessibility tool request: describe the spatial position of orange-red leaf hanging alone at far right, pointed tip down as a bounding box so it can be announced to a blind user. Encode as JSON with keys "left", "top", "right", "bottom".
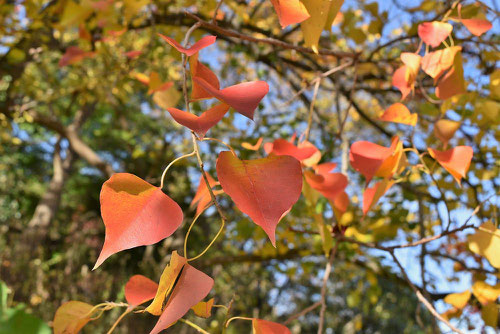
{"left": 428, "top": 146, "right": 473, "bottom": 185}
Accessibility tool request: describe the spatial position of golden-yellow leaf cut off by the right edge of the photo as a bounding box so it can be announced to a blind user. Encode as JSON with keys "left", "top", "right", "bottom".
{"left": 467, "top": 222, "right": 500, "bottom": 268}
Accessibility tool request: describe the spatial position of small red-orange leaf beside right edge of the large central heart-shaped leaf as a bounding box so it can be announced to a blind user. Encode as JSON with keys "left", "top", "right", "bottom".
{"left": 304, "top": 164, "right": 348, "bottom": 201}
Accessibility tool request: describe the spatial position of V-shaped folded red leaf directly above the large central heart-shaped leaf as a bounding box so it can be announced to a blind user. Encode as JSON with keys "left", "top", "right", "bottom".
{"left": 167, "top": 103, "right": 229, "bottom": 138}
